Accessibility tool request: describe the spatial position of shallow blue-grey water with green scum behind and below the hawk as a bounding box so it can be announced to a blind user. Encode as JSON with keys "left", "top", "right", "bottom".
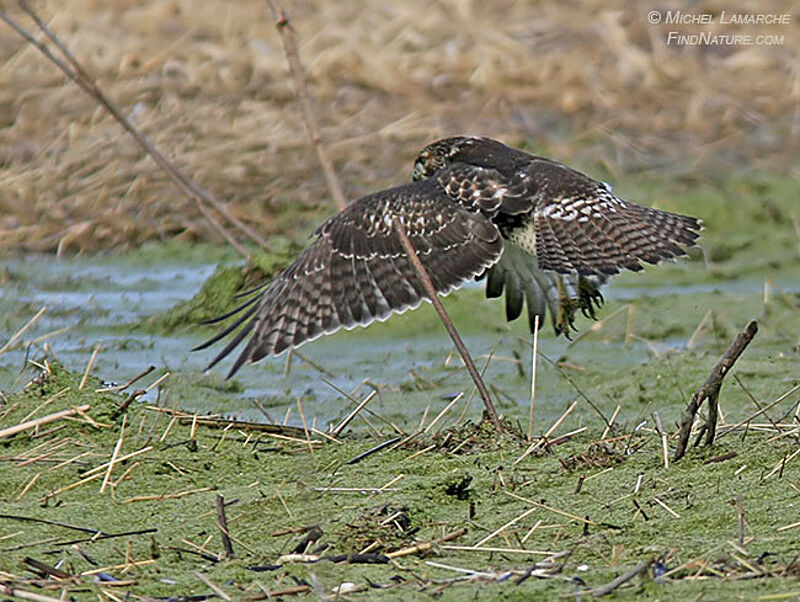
{"left": 0, "top": 247, "right": 800, "bottom": 425}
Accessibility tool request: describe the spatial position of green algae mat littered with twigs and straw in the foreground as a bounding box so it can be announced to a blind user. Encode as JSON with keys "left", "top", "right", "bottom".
{"left": 0, "top": 346, "right": 800, "bottom": 600}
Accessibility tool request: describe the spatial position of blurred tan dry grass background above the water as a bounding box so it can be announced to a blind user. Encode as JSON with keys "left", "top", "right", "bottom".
{"left": 0, "top": 0, "right": 800, "bottom": 252}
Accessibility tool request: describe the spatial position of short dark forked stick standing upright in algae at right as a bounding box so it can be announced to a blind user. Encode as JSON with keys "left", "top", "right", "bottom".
{"left": 675, "top": 320, "right": 758, "bottom": 460}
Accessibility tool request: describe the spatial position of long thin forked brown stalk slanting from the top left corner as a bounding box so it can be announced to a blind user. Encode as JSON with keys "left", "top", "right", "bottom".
{"left": 0, "top": 0, "right": 271, "bottom": 258}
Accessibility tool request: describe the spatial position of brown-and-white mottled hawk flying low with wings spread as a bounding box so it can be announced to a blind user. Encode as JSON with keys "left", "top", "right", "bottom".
{"left": 197, "top": 137, "right": 701, "bottom": 377}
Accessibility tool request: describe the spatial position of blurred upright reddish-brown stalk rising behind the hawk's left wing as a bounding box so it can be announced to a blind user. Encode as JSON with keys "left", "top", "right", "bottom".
{"left": 266, "top": 0, "right": 347, "bottom": 211}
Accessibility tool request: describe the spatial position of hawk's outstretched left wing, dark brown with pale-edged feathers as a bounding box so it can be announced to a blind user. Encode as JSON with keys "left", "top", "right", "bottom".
{"left": 197, "top": 180, "right": 503, "bottom": 377}
